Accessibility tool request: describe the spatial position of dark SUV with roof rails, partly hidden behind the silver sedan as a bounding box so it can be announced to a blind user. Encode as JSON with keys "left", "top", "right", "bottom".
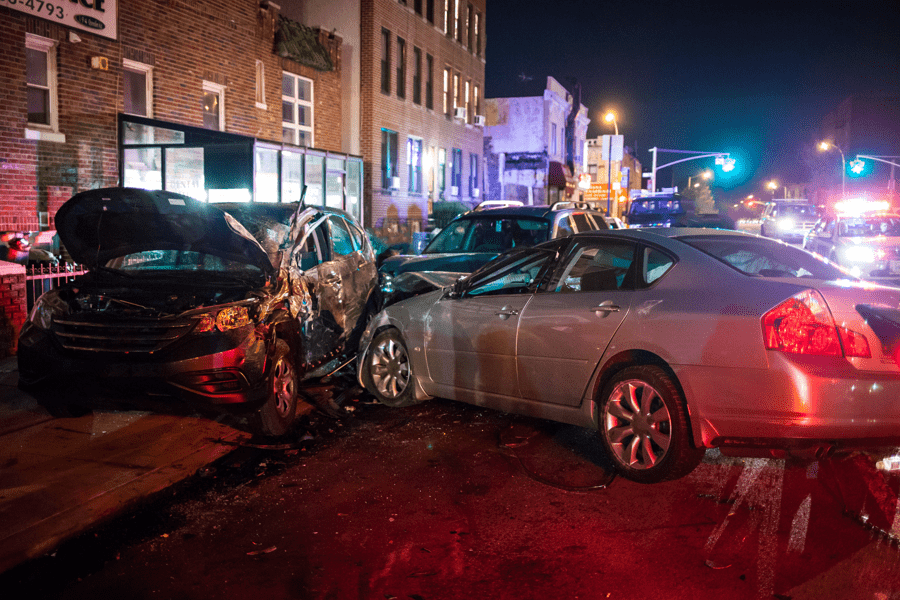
{"left": 380, "top": 202, "right": 609, "bottom": 304}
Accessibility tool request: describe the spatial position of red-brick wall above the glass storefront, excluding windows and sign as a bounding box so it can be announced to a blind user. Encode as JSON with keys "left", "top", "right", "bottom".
{"left": 0, "top": 0, "right": 341, "bottom": 230}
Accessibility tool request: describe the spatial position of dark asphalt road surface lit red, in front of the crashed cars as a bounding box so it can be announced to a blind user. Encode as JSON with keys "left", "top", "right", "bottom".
{"left": 0, "top": 376, "right": 900, "bottom": 600}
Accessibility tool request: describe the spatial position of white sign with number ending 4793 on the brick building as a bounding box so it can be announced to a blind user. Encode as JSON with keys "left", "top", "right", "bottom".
{"left": 0, "top": 0, "right": 118, "bottom": 40}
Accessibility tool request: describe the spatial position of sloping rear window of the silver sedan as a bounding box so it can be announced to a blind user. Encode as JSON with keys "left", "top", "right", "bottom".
{"left": 678, "top": 236, "right": 856, "bottom": 280}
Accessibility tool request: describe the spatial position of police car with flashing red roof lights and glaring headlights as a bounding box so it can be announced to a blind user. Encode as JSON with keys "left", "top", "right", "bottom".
{"left": 803, "top": 201, "right": 900, "bottom": 282}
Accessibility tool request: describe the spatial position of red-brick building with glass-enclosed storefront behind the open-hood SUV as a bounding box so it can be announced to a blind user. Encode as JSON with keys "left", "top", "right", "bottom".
{"left": 0, "top": 0, "right": 363, "bottom": 356}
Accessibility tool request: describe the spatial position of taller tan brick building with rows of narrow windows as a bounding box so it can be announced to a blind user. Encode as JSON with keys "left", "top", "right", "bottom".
{"left": 294, "top": 0, "right": 485, "bottom": 243}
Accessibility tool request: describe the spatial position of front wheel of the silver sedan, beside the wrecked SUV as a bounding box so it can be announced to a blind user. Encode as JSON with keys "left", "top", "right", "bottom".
{"left": 362, "top": 329, "right": 417, "bottom": 408}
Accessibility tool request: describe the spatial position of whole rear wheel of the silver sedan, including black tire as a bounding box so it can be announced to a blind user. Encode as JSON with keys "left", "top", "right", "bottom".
{"left": 597, "top": 365, "right": 705, "bottom": 483}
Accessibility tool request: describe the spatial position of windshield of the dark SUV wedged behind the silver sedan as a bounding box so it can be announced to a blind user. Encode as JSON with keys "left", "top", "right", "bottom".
{"left": 423, "top": 215, "right": 550, "bottom": 254}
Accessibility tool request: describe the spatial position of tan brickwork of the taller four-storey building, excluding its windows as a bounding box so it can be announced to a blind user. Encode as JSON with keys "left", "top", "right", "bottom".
{"left": 360, "top": 0, "right": 485, "bottom": 243}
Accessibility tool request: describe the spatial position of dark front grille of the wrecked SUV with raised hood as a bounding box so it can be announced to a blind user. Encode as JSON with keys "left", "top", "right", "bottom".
{"left": 53, "top": 317, "right": 194, "bottom": 354}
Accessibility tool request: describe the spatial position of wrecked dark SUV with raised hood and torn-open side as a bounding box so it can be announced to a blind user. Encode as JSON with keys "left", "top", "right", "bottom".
{"left": 18, "top": 188, "right": 378, "bottom": 435}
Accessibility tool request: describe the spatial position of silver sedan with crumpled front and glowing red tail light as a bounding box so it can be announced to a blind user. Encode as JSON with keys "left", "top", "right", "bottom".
{"left": 358, "top": 228, "right": 900, "bottom": 483}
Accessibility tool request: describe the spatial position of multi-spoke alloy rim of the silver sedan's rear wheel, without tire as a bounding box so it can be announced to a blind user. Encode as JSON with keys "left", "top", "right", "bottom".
{"left": 603, "top": 379, "right": 672, "bottom": 469}
